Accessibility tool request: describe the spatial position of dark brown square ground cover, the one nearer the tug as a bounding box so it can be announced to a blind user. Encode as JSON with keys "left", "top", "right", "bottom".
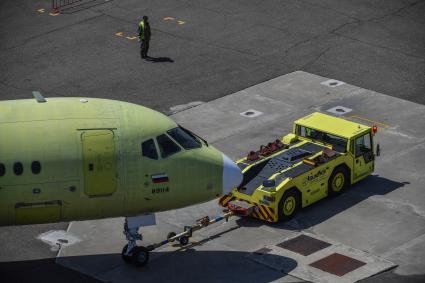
{"left": 277, "top": 235, "right": 331, "bottom": 256}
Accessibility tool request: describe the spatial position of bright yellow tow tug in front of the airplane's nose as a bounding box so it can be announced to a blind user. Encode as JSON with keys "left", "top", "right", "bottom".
{"left": 219, "top": 112, "right": 380, "bottom": 222}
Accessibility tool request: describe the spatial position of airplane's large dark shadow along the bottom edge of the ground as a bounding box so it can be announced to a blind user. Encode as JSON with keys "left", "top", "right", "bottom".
{"left": 0, "top": 249, "right": 297, "bottom": 283}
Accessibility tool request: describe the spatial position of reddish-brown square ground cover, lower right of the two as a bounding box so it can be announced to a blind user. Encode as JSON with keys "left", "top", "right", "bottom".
{"left": 310, "top": 253, "right": 366, "bottom": 276}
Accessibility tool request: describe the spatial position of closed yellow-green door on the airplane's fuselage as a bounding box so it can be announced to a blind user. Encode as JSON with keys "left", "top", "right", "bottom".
{"left": 81, "top": 130, "right": 117, "bottom": 196}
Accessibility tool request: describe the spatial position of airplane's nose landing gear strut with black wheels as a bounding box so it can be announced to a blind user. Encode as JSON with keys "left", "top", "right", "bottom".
{"left": 121, "top": 217, "right": 149, "bottom": 267}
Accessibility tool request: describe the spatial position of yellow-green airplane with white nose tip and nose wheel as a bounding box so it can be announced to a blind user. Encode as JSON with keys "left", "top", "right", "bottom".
{"left": 0, "top": 92, "right": 242, "bottom": 265}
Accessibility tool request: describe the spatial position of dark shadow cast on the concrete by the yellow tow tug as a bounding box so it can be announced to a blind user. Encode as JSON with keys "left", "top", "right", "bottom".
{"left": 237, "top": 175, "right": 409, "bottom": 230}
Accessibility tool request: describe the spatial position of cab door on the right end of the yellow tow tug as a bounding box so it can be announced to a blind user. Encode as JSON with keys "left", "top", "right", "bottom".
{"left": 354, "top": 133, "right": 374, "bottom": 181}
